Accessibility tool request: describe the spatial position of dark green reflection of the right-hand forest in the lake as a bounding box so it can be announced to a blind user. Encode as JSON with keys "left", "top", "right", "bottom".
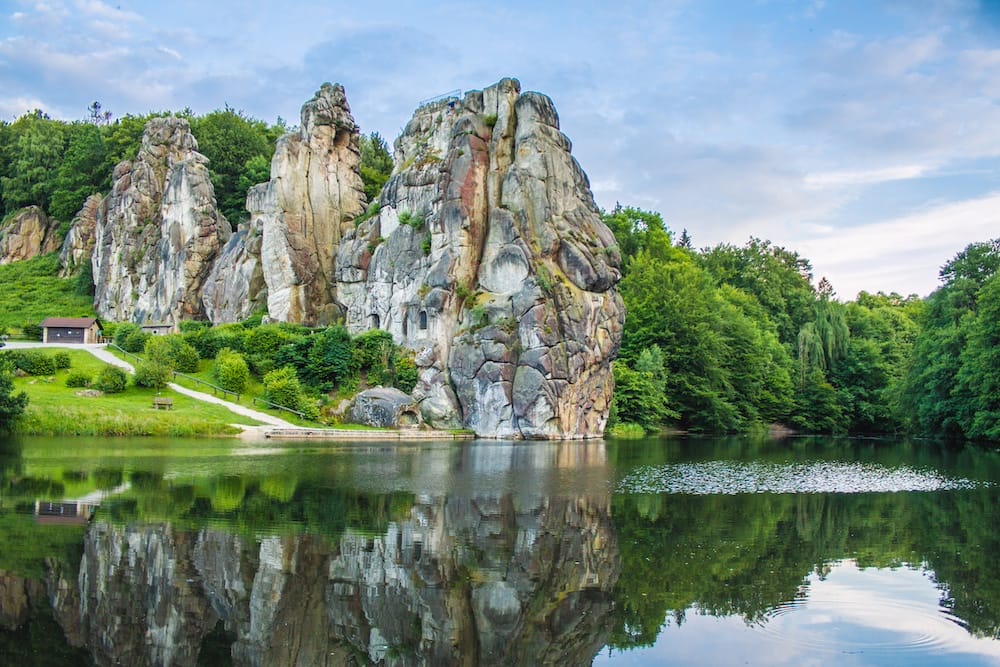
{"left": 611, "top": 488, "right": 1000, "bottom": 648}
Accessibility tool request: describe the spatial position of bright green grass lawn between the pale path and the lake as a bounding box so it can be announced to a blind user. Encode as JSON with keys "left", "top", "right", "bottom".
{"left": 14, "top": 350, "right": 258, "bottom": 436}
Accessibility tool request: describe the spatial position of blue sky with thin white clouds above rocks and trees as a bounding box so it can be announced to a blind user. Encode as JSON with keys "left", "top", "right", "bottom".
{"left": 0, "top": 0, "right": 1000, "bottom": 300}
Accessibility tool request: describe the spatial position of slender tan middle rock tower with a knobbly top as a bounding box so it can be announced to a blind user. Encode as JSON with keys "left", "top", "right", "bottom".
{"left": 256, "top": 84, "right": 365, "bottom": 325}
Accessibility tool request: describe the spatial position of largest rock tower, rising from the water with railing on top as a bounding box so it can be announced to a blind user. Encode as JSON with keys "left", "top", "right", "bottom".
{"left": 337, "top": 79, "right": 625, "bottom": 438}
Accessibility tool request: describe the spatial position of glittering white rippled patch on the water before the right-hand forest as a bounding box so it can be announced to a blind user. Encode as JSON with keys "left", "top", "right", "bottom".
{"left": 617, "top": 461, "right": 990, "bottom": 495}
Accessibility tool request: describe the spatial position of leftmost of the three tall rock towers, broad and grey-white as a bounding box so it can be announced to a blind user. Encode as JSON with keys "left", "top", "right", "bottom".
{"left": 93, "top": 117, "right": 230, "bottom": 322}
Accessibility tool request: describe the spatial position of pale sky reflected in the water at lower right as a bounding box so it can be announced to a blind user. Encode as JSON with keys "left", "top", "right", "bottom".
{"left": 594, "top": 561, "right": 1000, "bottom": 667}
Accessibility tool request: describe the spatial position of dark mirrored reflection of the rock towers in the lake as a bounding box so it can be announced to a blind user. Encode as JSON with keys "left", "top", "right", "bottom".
{"left": 49, "top": 450, "right": 620, "bottom": 666}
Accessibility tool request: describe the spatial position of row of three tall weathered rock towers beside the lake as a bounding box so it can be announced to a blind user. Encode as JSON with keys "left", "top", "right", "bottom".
{"left": 72, "top": 79, "right": 625, "bottom": 438}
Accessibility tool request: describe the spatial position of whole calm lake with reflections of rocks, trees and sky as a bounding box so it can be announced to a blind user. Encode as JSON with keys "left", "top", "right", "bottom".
{"left": 0, "top": 438, "right": 1000, "bottom": 667}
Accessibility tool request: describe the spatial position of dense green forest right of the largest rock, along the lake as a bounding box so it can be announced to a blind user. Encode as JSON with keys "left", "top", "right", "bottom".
{"left": 604, "top": 206, "right": 1000, "bottom": 441}
